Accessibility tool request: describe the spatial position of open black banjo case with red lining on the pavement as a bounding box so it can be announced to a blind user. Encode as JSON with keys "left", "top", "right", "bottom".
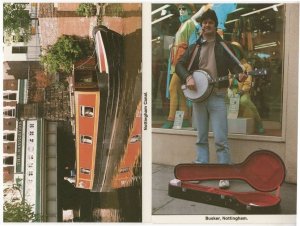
{"left": 169, "top": 150, "right": 285, "bottom": 214}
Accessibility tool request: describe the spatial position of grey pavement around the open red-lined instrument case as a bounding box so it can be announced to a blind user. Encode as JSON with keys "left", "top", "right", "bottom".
{"left": 152, "top": 164, "right": 297, "bottom": 215}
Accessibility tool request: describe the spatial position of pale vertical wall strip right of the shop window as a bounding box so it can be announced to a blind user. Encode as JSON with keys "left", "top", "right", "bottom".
{"left": 283, "top": 4, "right": 299, "bottom": 181}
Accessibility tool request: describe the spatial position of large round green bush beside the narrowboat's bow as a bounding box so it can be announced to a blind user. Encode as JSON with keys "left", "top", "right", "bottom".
{"left": 41, "top": 35, "right": 91, "bottom": 74}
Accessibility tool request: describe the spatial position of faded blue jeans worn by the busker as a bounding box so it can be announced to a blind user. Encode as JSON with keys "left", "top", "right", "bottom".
{"left": 193, "top": 93, "right": 231, "bottom": 164}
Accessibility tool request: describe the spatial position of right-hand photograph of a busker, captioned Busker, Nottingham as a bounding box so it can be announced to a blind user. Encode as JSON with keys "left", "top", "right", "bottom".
{"left": 151, "top": 3, "right": 299, "bottom": 219}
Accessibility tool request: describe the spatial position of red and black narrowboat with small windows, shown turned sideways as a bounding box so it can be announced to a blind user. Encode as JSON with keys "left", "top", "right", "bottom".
{"left": 73, "top": 26, "right": 123, "bottom": 192}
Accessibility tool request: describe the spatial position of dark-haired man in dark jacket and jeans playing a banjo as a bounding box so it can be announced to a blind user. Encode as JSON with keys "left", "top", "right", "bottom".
{"left": 176, "top": 9, "right": 247, "bottom": 188}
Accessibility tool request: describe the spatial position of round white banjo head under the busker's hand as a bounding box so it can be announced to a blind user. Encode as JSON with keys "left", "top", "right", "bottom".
{"left": 181, "top": 70, "right": 213, "bottom": 102}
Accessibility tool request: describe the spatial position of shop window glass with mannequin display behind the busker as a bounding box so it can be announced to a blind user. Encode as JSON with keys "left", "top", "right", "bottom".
{"left": 152, "top": 4, "right": 285, "bottom": 136}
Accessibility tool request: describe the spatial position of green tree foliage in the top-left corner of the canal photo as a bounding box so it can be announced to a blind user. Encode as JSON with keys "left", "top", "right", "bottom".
{"left": 3, "top": 3, "right": 31, "bottom": 42}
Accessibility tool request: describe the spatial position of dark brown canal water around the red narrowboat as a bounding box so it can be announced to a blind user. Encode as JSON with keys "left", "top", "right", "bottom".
{"left": 58, "top": 30, "right": 142, "bottom": 222}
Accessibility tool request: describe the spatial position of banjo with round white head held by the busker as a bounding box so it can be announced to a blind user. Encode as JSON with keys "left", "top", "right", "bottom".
{"left": 181, "top": 69, "right": 267, "bottom": 103}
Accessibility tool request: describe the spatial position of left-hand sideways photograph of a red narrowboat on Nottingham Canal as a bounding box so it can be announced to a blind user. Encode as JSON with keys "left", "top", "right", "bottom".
{"left": 2, "top": 2, "right": 142, "bottom": 222}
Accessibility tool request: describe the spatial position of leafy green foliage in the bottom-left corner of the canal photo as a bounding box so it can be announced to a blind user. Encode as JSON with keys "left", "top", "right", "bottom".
{"left": 3, "top": 201, "right": 39, "bottom": 222}
